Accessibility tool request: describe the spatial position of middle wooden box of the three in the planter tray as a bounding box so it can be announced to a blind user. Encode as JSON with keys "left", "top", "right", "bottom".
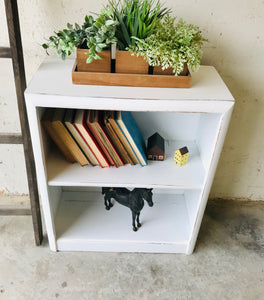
{"left": 115, "top": 50, "right": 149, "bottom": 74}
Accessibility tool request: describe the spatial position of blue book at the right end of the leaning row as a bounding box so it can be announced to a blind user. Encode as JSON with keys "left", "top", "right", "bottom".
{"left": 116, "top": 111, "right": 148, "bottom": 166}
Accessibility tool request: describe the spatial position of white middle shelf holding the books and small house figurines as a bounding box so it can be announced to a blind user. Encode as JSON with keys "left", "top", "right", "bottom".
{"left": 47, "top": 141, "right": 205, "bottom": 189}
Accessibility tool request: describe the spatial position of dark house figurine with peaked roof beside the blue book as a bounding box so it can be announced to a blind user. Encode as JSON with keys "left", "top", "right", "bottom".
{"left": 147, "top": 132, "right": 165, "bottom": 160}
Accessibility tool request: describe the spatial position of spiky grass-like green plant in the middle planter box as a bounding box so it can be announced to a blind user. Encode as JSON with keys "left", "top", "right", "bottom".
{"left": 109, "top": 0, "right": 170, "bottom": 50}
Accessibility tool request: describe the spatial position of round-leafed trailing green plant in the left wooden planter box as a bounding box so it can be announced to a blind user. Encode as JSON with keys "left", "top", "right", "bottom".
{"left": 42, "top": 9, "right": 119, "bottom": 63}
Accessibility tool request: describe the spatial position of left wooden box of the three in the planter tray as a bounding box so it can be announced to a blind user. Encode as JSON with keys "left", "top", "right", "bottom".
{"left": 76, "top": 49, "right": 111, "bottom": 73}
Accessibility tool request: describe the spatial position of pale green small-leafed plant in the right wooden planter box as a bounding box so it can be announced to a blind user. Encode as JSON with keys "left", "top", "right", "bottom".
{"left": 129, "top": 15, "right": 207, "bottom": 75}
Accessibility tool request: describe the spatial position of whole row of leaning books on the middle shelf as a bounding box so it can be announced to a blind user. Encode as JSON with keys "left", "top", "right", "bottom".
{"left": 41, "top": 108, "right": 147, "bottom": 168}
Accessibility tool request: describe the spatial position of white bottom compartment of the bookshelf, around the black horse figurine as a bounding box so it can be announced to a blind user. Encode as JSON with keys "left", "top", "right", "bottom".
{"left": 55, "top": 192, "right": 190, "bottom": 252}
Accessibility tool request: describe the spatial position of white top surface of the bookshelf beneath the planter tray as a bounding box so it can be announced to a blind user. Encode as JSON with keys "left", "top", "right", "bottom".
{"left": 26, "top": 57, "right": 234, "bottom": 101}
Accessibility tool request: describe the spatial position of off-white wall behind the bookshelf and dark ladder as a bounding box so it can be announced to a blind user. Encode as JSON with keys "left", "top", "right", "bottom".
{"left": 0, "top": 0, "right": 264, "bottom": 200}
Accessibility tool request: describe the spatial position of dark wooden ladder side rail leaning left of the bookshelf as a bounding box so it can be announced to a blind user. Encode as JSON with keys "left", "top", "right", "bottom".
{"left": 5, "top": 0, "right": 43, "bottom": 246}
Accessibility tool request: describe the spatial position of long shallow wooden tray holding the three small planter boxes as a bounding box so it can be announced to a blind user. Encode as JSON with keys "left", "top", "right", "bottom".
{"left": 72, "top": 65, "right": 191, "bottom": 88}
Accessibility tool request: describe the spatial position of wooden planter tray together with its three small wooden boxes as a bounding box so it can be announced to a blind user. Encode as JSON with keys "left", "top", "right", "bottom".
{"left": 72, "top": 49, "right": 191, "bottom": 88}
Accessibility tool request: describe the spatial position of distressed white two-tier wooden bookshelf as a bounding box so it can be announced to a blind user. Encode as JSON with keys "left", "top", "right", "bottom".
{"left": 25, "top": 59, "right": 234, "bottom": 254}
